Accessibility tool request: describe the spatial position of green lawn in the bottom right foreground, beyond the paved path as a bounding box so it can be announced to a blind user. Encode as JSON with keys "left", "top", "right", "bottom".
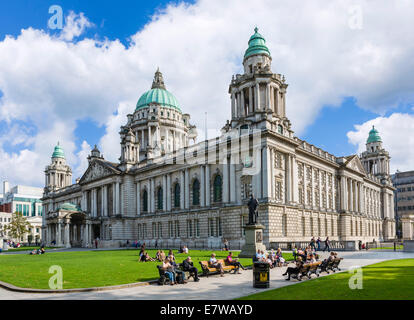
{"left": 240, "top": 259, "right": 414, "bottom": 300}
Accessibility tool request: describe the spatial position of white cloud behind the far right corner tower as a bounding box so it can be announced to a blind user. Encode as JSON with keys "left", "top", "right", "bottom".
{"left": 347, "top": 113, "right": 414, "bottom": 173}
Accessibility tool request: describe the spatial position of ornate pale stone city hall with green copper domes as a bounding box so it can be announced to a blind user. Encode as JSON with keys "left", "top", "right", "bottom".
{"left": 42, "top": 29, "right": 395, "bottom": 249}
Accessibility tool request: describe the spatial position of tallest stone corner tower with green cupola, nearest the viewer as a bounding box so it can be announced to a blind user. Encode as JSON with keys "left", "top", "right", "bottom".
{"left": 223, "top": 28, "right": 293, "bottom": 137}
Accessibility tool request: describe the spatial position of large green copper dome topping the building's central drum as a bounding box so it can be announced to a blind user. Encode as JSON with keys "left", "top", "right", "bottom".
{"left": 135, "top": 70, "right": 181, "bottom": 112}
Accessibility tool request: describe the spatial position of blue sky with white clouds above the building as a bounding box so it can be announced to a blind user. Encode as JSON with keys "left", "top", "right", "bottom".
{"left": 0, "top": 0, "right": 414, "bottom": 192}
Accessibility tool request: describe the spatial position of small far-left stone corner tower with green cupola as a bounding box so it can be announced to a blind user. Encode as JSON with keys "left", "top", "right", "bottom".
{"left": 45, "top": 142, "right": 72, "bottom": 193}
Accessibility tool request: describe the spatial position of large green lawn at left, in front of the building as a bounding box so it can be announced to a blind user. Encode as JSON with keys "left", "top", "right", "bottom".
{"left": 0, "top": 250, "right": 291, "bottom": 289}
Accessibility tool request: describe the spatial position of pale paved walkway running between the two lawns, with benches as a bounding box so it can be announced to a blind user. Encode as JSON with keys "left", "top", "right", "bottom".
{"left": 0, "top": 251, "right": 414, "bottom": 300}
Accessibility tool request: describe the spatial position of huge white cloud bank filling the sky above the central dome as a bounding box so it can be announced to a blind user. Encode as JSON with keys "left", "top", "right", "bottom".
{"left": 0, "top": 0, "right": 414, "bottom": 188}
